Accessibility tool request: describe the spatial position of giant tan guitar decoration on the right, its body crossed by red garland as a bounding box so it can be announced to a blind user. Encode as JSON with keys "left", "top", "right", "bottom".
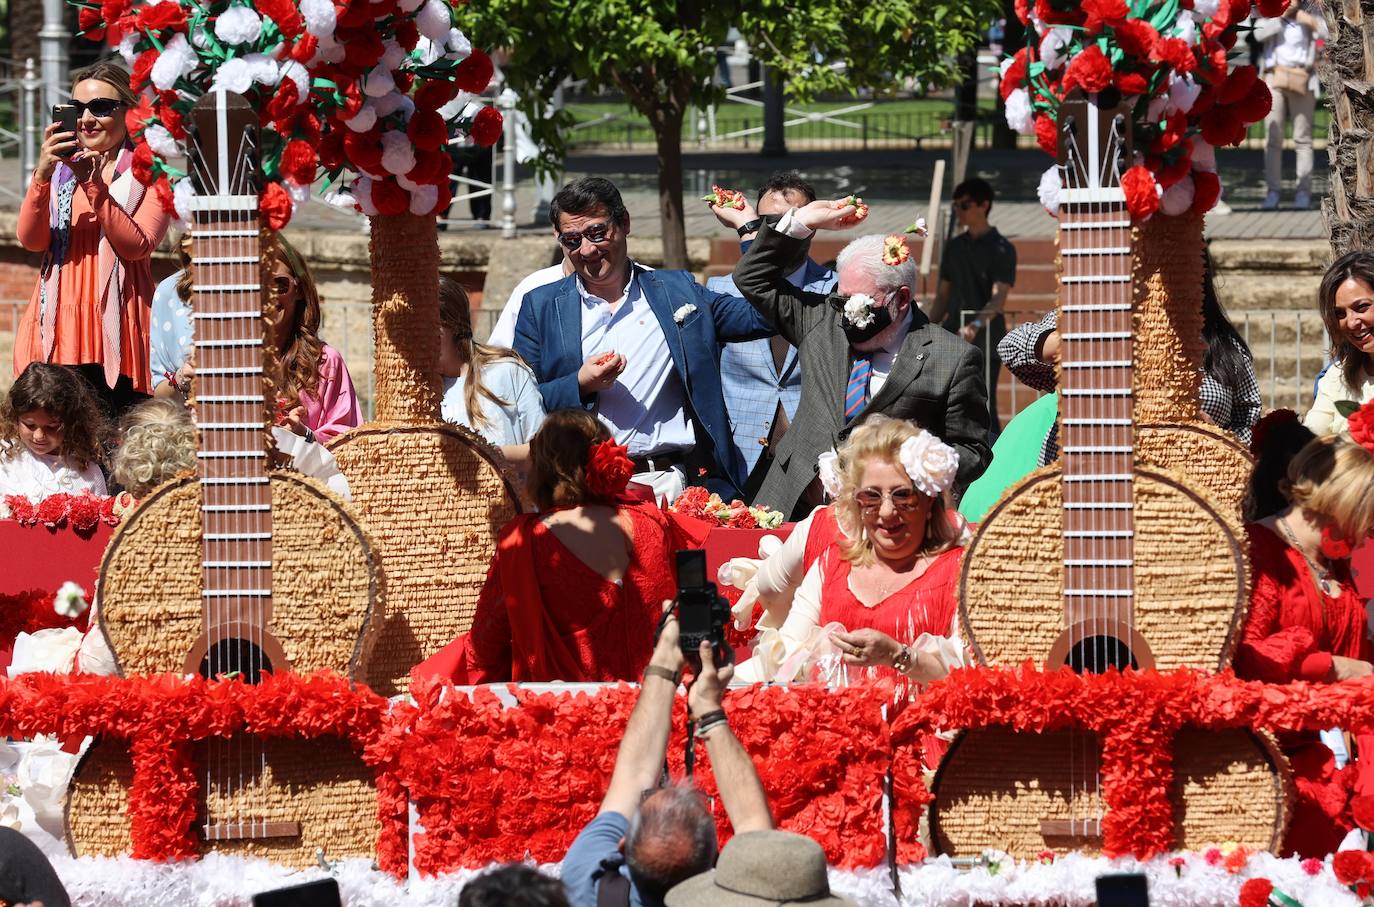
{"left": 930, "top": 91, "right": 1286, "bottom": 858}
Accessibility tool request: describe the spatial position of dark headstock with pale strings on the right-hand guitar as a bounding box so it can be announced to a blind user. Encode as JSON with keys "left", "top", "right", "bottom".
{"left": 1057, "top": 88, "right": 1131, "bottom": 190}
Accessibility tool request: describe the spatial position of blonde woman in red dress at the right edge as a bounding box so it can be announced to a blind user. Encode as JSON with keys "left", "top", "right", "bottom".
{"left": 1235, "top": 405, "right": 1374, "bottom": 858}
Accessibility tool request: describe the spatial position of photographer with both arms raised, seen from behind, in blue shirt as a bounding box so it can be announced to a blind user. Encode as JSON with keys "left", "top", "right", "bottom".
{"left": 562, "top": 602, "right": 772, "bottom": 907}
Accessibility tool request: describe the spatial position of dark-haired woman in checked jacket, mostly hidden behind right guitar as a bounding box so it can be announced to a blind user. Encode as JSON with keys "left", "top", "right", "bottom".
{"left": 998, "top": 253, "right": 1263, "bottom": 466}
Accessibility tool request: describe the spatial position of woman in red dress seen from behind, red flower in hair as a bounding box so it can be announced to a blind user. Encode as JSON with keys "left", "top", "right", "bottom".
{"left": 411, "top": 410, "right": 705, "bottom": 684}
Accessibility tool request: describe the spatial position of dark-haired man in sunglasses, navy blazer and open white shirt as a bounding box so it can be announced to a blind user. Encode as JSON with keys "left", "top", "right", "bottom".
{"left": 515, "top": 177, "right": 775, "bottom": 500}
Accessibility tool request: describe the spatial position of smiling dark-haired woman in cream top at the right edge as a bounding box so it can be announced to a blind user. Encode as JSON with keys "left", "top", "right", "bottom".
{"left": 1303, "top": 245, "right": 1374, "bottom": 434}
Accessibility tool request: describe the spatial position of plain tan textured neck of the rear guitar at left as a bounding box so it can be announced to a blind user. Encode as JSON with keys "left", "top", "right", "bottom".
{"left": 370, "top": 214, "right": 444, "bottom": 425}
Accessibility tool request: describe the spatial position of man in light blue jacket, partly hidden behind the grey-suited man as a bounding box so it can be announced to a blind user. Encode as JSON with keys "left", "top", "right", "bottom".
{"left": 706, "top": 170, "right": 835, "bottom": 494}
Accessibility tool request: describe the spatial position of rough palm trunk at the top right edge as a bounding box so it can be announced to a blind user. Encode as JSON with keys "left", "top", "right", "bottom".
{"left": 1318, "top": 0, "right": 1374, "bottom": 256}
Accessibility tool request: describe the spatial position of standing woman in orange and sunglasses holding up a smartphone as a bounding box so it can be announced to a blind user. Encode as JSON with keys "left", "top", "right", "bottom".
{"left": 14, "top": 62, "right": 168, "bottom": 415}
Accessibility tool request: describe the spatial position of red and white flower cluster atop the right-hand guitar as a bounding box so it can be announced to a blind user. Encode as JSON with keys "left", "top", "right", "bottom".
{"left": 1000, "top": 0, "right": 1287, "bottom": 220}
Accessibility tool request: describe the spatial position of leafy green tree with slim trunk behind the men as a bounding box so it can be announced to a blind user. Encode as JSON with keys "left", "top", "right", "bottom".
{"left": 458, "top": 0, "right": 1002, "bottom": 268}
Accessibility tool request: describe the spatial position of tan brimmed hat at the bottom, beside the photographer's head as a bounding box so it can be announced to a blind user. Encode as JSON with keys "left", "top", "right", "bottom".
{"left": 664, "top": 831, "right": 857, "bottom": 907}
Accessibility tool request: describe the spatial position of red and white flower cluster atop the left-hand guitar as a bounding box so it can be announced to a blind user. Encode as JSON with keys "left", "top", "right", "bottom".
{"left": 70, "top": 0, "right": 502, "bottom": 229}
